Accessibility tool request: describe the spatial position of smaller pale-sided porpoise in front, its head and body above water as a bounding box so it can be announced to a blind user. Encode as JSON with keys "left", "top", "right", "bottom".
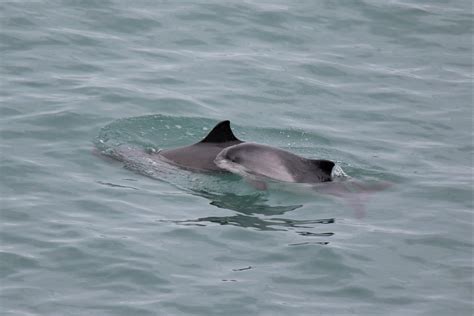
{"left": 215, "top": 143, "right": 335, "bottom": 183}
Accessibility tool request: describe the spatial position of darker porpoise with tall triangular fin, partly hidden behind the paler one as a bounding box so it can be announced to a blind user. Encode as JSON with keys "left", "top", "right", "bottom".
{"left": 158, "top": 121, "right": 242, "bottom": 171}
